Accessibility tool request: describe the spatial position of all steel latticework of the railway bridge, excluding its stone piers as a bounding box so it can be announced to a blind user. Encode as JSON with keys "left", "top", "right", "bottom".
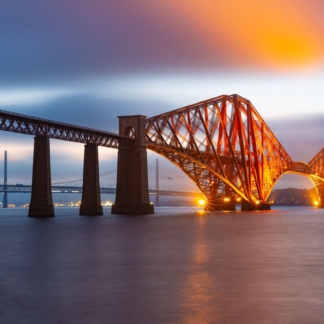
{"left": 0, "top": 95, "right": 324, "bottom": 207}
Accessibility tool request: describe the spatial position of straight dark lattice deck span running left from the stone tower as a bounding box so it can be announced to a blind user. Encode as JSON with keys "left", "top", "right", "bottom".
{"left": 0, "top": 110, "right": 134, "bottom": 149}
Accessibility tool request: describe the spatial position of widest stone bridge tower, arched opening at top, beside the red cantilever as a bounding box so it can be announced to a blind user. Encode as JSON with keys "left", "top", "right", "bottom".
{"left": 111, "top": 115, "right": 154, "bottom": 215}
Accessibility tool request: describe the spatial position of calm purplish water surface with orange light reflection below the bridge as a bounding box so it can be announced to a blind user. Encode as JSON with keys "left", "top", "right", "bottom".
{"left": 0, "top": 207, "right": 324, "bottom": 324}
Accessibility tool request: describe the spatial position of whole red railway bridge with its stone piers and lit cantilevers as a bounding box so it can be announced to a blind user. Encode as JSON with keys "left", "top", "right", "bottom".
{"left": 0, "top": 95, "right": 324, "bottom": 217}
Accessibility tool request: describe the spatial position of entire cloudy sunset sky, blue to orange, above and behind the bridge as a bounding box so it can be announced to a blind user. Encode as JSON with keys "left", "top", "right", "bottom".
{"left": 0, "top": 0, "right": 324, "bottom": 188}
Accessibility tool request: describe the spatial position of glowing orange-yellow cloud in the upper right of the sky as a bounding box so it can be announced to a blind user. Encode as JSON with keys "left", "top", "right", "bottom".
{"left": 161, "top": 0, "right": 323, "bottom": 69}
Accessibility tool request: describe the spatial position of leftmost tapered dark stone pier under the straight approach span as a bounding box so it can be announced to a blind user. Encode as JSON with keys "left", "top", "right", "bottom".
{"left": 28, "top": 136, "right": 54, "bottom": 217}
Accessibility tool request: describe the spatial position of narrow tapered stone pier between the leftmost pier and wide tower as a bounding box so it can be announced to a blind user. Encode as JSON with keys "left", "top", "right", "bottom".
{"left": 79, "top": 144, "right": 103, "bottom": 216}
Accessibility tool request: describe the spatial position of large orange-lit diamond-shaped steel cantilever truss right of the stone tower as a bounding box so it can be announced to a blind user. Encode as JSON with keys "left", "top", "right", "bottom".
{"left": 146, "top": 95, "right": 311, "bottom": 202}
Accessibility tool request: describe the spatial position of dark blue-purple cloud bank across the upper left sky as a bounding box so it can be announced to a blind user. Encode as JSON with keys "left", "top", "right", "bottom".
{"left": 0, "top": 0, "right": 227, "bottom": 83}
